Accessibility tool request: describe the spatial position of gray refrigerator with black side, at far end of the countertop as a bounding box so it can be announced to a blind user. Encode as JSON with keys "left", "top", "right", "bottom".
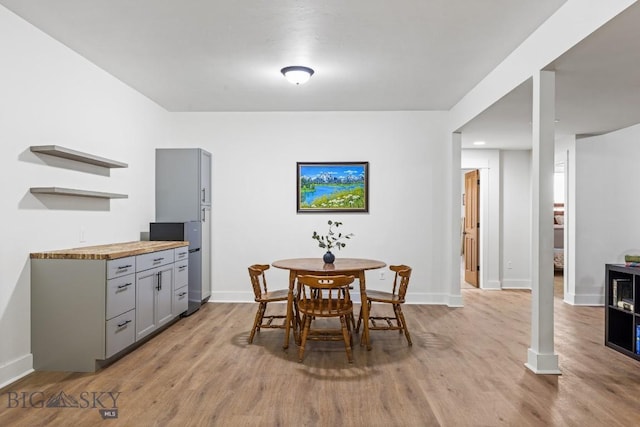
{"left": 149, "top": 221, "right": 205, "bottom": 316}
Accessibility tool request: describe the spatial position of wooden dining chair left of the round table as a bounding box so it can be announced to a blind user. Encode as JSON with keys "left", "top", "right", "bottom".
{"left": 249, "top": 264, "right": 289, "bottom": 344}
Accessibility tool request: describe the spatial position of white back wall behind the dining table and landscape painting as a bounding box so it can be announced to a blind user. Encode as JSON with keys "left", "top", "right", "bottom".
{"left": 169, "top": 112, "right": 449, "bottom": 303}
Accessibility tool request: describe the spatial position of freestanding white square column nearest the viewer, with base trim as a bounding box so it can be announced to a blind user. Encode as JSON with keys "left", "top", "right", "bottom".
{"left": 526, "top": 71, "right": 560, "bottom": 374}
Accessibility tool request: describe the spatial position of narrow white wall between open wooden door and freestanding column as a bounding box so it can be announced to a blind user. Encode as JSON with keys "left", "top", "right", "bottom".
{"left": 501, "top": 150, "right": 532, "bottom": 289}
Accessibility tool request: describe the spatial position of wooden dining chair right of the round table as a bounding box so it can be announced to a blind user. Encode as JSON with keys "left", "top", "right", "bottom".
{"left": 356, "top": 265, "right": 413, "bottom": 345}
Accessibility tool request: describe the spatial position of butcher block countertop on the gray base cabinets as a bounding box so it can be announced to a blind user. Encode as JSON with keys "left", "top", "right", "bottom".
{"left": 31, "top": 241, "right": 189, "bottom": 260}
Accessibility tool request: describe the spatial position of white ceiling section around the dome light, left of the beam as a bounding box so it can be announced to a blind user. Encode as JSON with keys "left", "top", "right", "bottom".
{"left": 0, "top": 0, "right": 566, "bottom": 111}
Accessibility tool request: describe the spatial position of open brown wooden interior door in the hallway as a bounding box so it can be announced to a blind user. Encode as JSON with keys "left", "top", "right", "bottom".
{"left": 463, "top": 170, "right": 480, "bottom": 287}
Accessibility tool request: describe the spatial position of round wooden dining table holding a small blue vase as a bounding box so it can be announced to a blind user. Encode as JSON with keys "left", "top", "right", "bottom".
{"left": 271, "top": 258, "right": 387, "bottom": 350}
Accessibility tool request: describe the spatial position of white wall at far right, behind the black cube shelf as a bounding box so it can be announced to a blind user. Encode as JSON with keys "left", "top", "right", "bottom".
{"left": 573, "top": 125, "right": 640, "bottom": 305}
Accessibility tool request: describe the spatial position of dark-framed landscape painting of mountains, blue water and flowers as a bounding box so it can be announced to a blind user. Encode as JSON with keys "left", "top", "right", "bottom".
{"left": 296, "top": 162, "right": 369, "bottom": 213}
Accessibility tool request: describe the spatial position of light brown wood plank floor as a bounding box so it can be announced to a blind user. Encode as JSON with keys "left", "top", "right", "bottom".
{"left": 0, "top": 282, "right": 640, "bottom": 427}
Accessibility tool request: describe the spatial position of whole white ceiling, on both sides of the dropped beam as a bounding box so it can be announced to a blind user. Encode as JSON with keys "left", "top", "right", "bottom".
{"left": 5, "top": 0, "right": 640, "bottom": 149}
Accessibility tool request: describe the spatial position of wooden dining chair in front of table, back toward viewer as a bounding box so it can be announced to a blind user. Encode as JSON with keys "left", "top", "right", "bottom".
{"left": 298, "top": 275, "right": 355, "bottom": 363}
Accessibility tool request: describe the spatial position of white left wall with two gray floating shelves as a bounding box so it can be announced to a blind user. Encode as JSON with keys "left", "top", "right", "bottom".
{"left": 0, "top": 7, "right": 167, "bottom": 386}
